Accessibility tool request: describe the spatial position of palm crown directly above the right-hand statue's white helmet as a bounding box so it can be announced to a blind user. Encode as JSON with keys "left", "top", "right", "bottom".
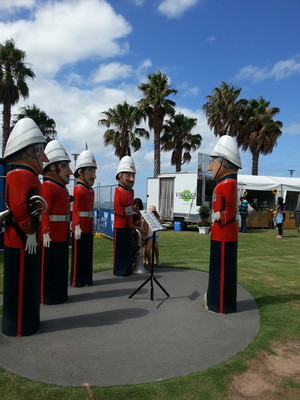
{"left": 203, "top": 82, "right": 247, "bottom": 136}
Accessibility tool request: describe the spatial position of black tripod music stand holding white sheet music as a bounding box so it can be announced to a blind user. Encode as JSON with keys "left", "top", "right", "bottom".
{"left": 129, "top": 210, "right": 170, "bottom": 301}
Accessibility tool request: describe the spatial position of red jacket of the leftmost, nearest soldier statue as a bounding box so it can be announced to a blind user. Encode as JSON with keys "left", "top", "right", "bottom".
{"left": 4, "top": 166, "right": 41, "bottom": 249}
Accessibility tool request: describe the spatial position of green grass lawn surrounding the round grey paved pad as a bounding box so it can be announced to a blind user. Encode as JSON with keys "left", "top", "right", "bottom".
{"left": 0, "top": 229, "right": 300, "bottom": 400}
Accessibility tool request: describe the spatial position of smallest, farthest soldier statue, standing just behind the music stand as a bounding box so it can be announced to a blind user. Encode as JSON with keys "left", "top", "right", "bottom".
{"left": 113, "top": 156, "right": 136, "bottom": 276}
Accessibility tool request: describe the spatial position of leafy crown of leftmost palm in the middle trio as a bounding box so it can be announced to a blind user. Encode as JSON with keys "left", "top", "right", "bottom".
{"left": 98, "top": 101, "right": 149, "bottom": 159}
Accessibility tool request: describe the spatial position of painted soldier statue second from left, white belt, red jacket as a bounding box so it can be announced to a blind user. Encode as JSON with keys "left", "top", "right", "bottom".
{"left": 41, "top": 140, "right": 72, "bottom": 305}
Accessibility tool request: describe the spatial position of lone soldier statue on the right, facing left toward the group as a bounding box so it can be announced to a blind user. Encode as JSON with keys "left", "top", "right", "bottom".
{"left": 205, "top": 135, "right": 242, "bottom": 314}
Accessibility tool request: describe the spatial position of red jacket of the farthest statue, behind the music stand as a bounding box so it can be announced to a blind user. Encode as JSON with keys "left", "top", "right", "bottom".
{"left": 114, "top": 185, "right": 134, "bottom": 228}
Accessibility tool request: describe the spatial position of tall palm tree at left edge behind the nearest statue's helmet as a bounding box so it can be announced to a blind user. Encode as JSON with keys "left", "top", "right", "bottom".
{"left": 0, "top": 39, "right": 35, "bottom": 154}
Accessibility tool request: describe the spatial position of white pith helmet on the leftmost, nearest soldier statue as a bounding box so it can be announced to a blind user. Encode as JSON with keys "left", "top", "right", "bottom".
{"left": 3, "top": 118, "right": 46, "bottom": 158}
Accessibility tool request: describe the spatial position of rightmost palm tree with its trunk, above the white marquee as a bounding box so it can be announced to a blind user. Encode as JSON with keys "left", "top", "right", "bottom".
{"left": 237, "top": 97, "right": 283, "bottom": 175}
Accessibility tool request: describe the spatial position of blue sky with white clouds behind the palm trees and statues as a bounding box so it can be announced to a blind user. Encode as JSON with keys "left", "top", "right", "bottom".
{"left": 0, "top": 0, "right": 300, "bottom": 200}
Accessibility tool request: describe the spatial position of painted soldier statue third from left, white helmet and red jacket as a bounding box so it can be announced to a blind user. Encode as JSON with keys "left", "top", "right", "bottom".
{"left": 70, "top": 150, "right": 97, "bottom": 287}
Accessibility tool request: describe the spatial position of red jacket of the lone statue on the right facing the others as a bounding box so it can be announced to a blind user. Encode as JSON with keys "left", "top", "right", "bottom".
{"left": 211, "top": 175, "right": 238, "bottom": 242}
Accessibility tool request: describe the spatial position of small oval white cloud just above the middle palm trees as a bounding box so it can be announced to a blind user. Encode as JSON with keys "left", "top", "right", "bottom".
{"left": 92, "top": 62, "right": 133, "bottom": 83}
